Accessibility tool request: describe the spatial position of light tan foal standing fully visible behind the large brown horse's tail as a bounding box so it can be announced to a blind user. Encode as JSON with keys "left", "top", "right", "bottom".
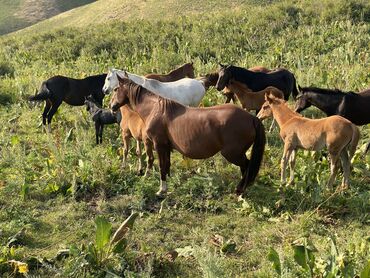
{"left": 257, "top": 93, "right": 360, "bottom": 189}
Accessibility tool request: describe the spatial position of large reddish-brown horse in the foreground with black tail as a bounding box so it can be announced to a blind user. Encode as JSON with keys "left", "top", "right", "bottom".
{"left": 111, "top": 77, "right": 266, "bottom": 195}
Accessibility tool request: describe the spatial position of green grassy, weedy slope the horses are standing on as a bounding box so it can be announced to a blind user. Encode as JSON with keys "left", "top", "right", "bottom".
{"left": 0, "top": 0, "right": 370, "bottom": 277}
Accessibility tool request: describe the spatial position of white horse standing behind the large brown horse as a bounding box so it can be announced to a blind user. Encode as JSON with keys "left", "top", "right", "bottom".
{"left": 103, "top": 69, "right": 206, "bottom": 107}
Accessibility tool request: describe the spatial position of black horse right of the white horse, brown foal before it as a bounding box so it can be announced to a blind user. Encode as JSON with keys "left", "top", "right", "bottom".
{"left": 216, "top": 64, "right": 298, "bottom": 100}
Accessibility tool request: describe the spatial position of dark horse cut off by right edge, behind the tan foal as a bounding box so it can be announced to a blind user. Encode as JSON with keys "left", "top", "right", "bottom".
{"left": 295, "top": 86, "right": 370, "bottom": 125}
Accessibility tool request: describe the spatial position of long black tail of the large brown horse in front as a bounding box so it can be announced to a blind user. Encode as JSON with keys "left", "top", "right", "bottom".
{"left": 243, "top": 117, "right": 266, "bottom": 191}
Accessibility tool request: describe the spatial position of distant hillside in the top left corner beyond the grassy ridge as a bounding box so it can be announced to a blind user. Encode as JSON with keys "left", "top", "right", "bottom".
{"left": 0, "top": 0, "right": 95, "bottom": 35}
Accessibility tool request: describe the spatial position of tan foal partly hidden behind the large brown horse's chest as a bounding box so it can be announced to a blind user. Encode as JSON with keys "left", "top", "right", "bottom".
{"left": 120, "top": 105, "right": 154, "bottom": 176}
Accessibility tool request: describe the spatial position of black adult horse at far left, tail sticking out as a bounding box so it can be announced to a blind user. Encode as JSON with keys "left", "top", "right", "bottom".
{"left": 29, "top": 74, "right": 107, "bottom": 132}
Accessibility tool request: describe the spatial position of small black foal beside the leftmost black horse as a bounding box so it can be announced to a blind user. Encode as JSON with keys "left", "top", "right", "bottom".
{"left": 85, "top": 96, "right": 121, "bottom": 145}
